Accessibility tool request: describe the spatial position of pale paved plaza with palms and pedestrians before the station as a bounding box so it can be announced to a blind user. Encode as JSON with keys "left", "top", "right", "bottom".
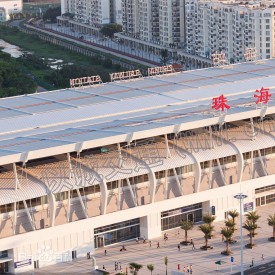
{"left": 29, "top": 203, "right": 275, "bottom": 275}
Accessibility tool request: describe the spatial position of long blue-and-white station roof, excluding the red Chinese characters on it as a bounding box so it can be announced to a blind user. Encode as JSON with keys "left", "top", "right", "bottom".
{"left": 0, "top": 59, "right": 275, "bottom": 165}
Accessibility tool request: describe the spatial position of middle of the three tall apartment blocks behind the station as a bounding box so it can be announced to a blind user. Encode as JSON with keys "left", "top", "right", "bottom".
{"left": 122, "top": 0, "right": 185, "bottom": 47}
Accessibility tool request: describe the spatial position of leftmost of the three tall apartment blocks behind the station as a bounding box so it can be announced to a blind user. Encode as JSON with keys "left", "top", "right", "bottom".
{"left": 61, "top": 0, "right": 122, "bottom": 26}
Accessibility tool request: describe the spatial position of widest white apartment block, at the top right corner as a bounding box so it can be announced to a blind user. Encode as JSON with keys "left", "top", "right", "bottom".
{"left": 186, "top": 0, "right": 275, "bottom": 62}
